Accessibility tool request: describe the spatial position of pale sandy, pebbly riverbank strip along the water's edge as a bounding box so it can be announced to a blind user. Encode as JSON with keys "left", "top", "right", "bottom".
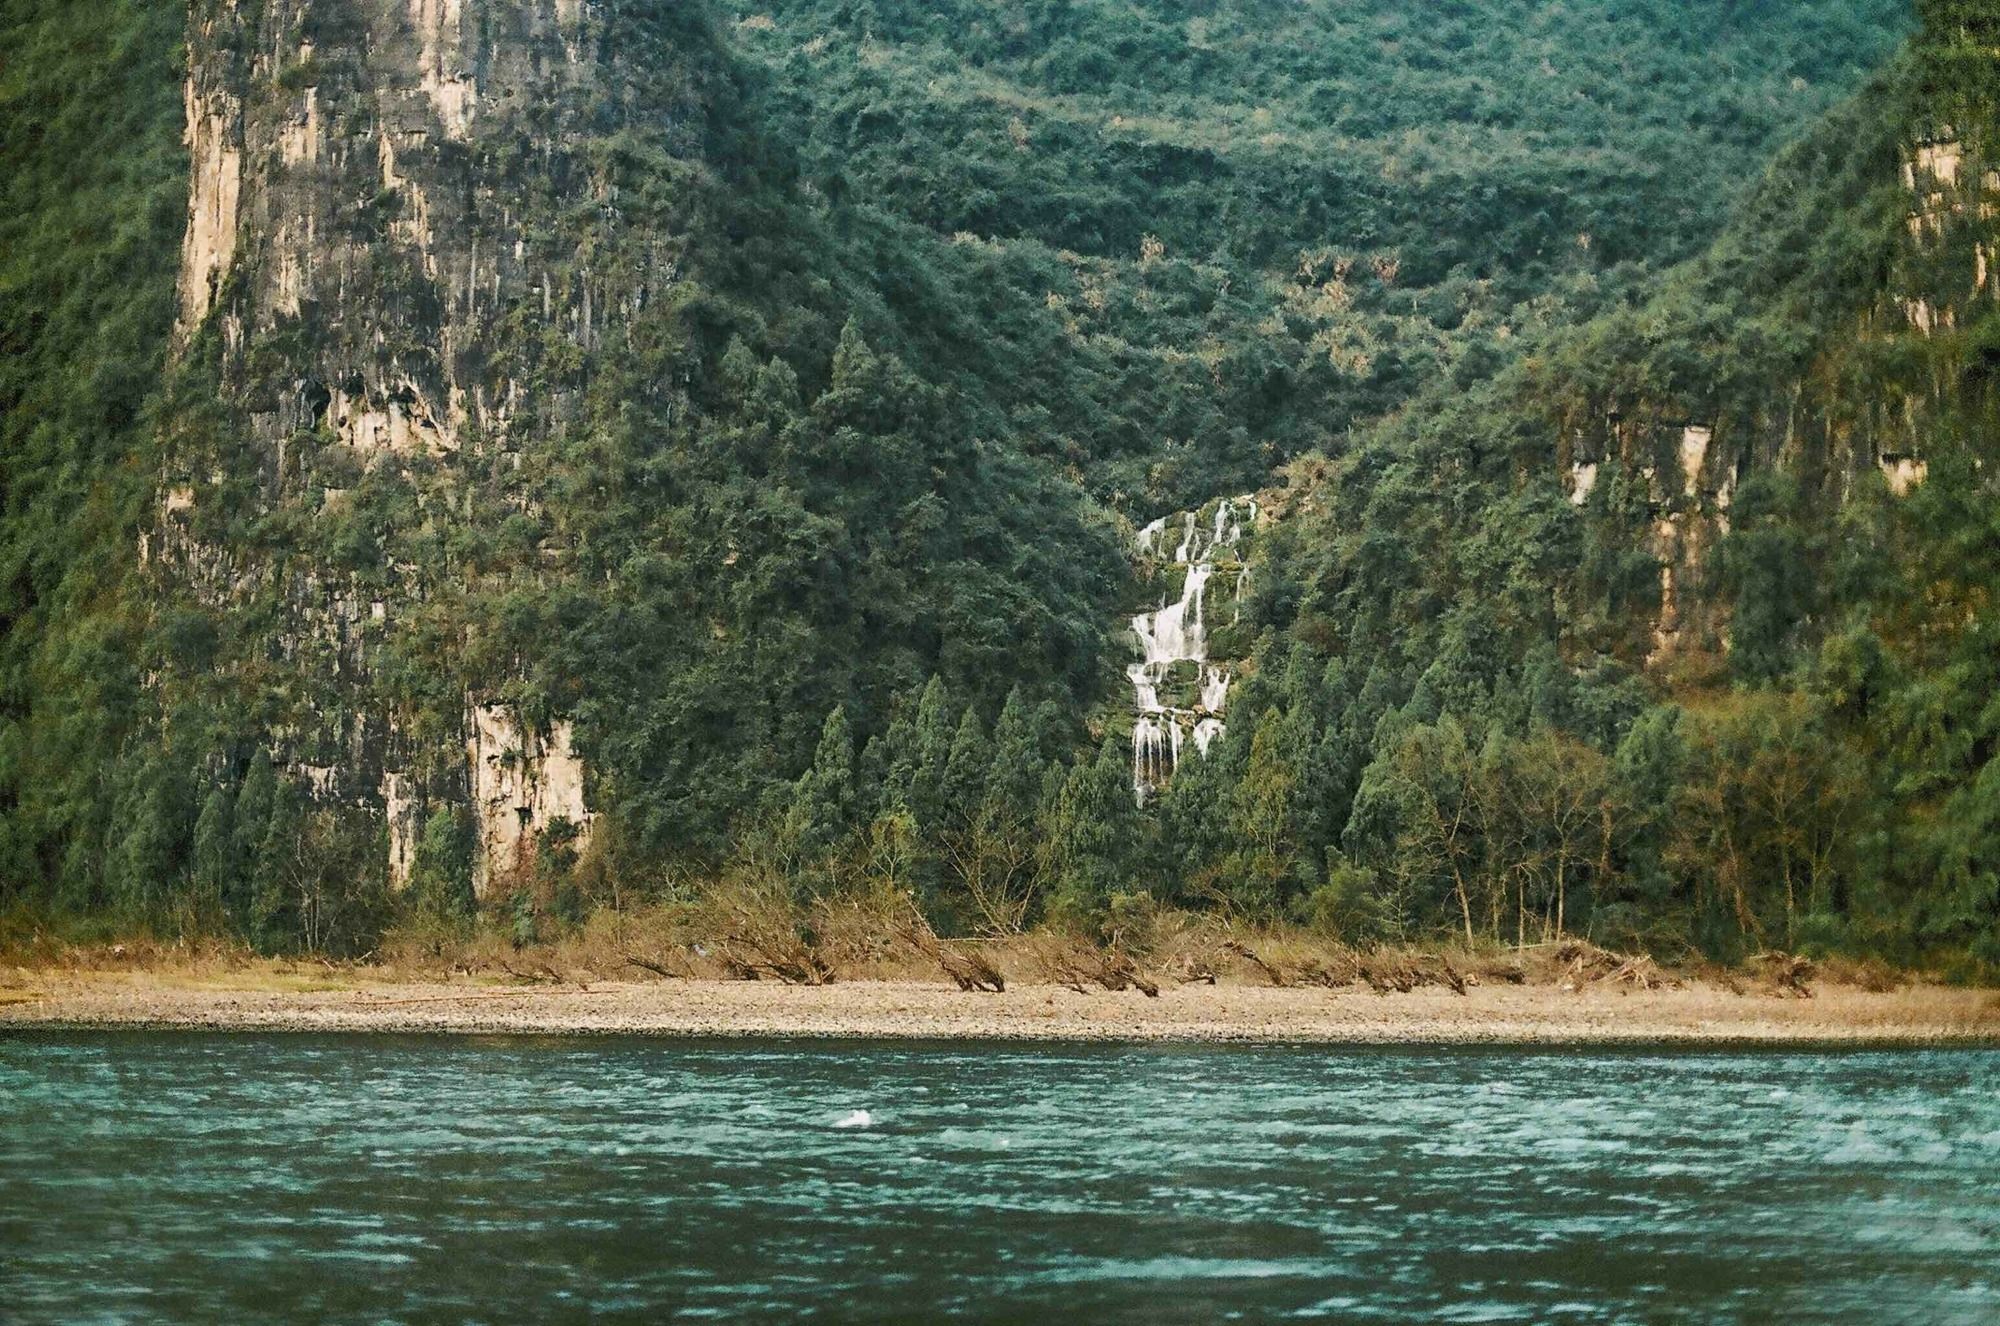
{"left": 0, "top": 972, "right": 2000, "bottom": 1044}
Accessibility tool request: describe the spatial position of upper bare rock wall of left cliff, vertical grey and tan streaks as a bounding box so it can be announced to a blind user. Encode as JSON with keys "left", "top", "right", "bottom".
{"left": 182, "top": 0, "right": 648, "bottom": 464}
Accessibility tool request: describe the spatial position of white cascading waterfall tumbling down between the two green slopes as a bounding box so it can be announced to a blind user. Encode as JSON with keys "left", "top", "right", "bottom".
{"left": 1126, "top": 496, "right": 1258, "bottom": 792}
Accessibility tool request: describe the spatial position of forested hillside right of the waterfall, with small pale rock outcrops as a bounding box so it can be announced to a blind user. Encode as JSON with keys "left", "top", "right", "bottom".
{"left": 1200, "top": 4, "right": 2000, "bottom": 964}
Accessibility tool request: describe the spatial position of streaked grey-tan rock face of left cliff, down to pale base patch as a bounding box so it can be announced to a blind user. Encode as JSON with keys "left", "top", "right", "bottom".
{"left": 162, "top": 0, "right": 706, "bottom": 886}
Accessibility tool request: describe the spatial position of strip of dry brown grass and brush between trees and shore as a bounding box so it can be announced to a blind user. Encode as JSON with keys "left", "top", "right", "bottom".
{"left": 0, "top": 904, "right": 1984, "bottom": 998}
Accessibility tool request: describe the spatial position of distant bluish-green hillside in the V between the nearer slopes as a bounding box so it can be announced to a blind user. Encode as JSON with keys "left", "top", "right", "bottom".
{"left": 728, "top": 0, "right": 1908, "bottom": 504}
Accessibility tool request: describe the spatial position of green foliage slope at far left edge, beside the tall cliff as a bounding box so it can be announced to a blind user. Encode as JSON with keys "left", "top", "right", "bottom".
{"left": 0, "top": 0, "right": 188, "bottom": 904}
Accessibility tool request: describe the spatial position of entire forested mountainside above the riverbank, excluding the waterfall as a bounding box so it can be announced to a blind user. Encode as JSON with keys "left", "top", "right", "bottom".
{"left": 0, "top": 0, "right": 2000, "bottom": 976}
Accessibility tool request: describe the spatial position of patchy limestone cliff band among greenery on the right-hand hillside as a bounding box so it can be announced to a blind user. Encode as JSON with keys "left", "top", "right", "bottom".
{"left": 1558, "top": 101, "right": 2000, "bottom": 666}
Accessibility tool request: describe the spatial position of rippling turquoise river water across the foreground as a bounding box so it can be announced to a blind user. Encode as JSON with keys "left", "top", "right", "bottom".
{"left": 0, "top": 1034, "right": 2000, "bottom": 1324}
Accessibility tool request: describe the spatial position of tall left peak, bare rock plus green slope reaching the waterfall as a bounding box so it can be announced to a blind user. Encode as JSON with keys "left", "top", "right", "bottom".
{"left": 140, "top": 0, "right": 1122, "bottom": 924}
